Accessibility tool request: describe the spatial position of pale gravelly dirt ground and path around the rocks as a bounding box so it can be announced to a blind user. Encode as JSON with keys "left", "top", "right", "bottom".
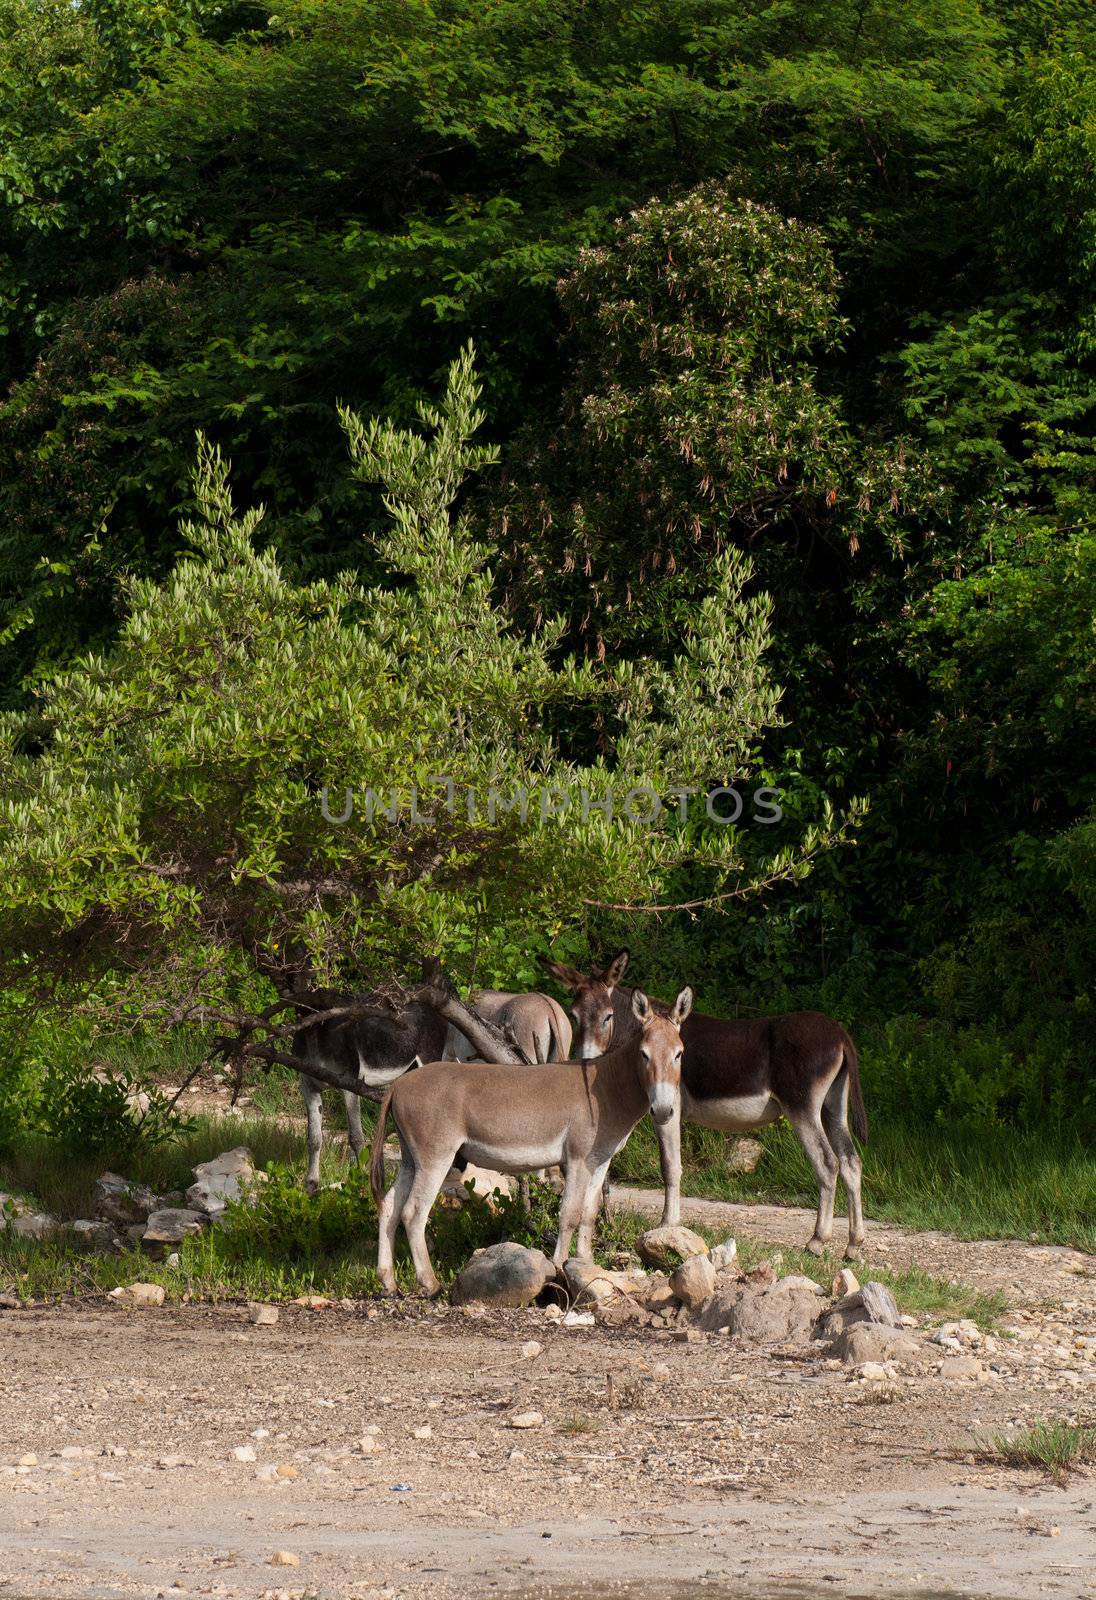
{"left": 0, "top": 1194, "right": 1096, "bottom": 1600}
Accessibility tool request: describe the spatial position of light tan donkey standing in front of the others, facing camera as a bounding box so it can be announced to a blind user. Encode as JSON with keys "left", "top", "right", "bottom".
{"left": 370, "top": 989, "right": 693, "bottom": 1294}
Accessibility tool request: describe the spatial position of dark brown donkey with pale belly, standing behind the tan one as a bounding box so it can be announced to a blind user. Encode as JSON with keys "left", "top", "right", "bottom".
{"left": 541, "top": 950, "right": 867, "bottom": 1261}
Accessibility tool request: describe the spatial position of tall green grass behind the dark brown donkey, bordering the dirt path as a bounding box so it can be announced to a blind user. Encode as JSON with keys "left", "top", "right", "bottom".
{"left": 613, "top": 1117, "right": 1096, "bottom": 1251}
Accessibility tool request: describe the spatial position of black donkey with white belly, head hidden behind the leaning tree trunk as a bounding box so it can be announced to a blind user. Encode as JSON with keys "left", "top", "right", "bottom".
{"left": 293, "top": 1000, "right": 450, "bottom": 1192}
